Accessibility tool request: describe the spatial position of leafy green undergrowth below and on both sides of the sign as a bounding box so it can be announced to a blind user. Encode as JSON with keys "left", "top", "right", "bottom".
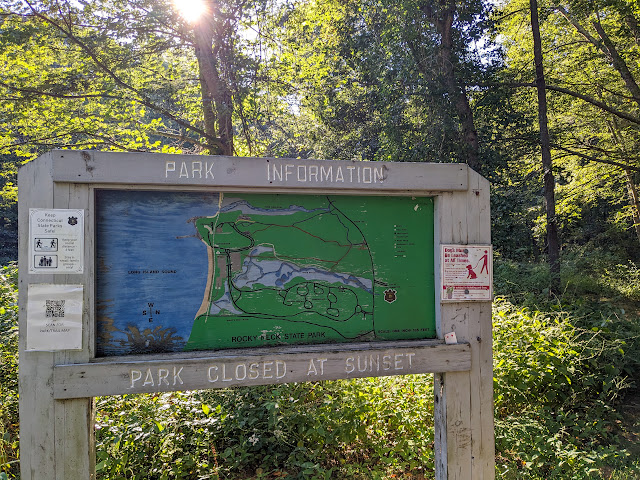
{"left": 0, "top": 252, "right": 640, "bottom": 480}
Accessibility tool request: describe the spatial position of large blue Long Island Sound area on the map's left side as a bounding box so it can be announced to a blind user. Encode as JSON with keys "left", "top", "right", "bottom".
{"left": 96, "top": 190, "right": 219, "bottom": 355}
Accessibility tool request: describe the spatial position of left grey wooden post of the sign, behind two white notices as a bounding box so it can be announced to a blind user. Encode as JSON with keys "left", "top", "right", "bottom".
{"left": 18, "top": 153, "right": 95, "bottom": 480}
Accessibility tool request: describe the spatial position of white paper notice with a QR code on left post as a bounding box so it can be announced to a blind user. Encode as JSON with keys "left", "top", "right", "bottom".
{"left": 27, "top": 284, "right": 83, "bottom": 351}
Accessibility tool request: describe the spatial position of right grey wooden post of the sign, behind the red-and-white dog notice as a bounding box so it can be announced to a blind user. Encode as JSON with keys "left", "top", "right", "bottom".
{"left": 434, "top": 170, "right": 495, "bottom": 480}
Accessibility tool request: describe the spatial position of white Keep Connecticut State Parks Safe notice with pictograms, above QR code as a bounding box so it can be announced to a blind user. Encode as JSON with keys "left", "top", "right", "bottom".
{"left": 29, "top": 208, "right": 84, "bottom": 274}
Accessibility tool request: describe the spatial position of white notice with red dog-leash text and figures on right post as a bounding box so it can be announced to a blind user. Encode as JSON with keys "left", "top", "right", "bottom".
{"left": 440, "top": 245, "right": 493, "bottom": 301}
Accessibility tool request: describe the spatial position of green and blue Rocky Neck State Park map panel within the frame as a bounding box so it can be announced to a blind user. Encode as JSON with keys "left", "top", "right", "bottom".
{"left": 96, "top": 190, "right": 436, "bottom": 356}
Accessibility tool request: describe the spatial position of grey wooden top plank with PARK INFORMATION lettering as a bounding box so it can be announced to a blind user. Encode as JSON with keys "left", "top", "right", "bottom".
{"left": 51, "top": 150, "right": 468, "bottom": 195}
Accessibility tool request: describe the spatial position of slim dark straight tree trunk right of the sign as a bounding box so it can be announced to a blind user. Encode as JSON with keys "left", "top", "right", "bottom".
{"left": 529, "top": 0, "right": 560, "bottom": 293}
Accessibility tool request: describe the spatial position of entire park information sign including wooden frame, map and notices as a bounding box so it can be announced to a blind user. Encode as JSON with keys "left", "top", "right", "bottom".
{"left": 19, "top": 151, "right": 494, "bottom": 480}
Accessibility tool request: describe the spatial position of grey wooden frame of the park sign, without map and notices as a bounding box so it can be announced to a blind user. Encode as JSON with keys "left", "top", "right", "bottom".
{"left": 18, "top": 150, "right": 495, "bottom": 480}
